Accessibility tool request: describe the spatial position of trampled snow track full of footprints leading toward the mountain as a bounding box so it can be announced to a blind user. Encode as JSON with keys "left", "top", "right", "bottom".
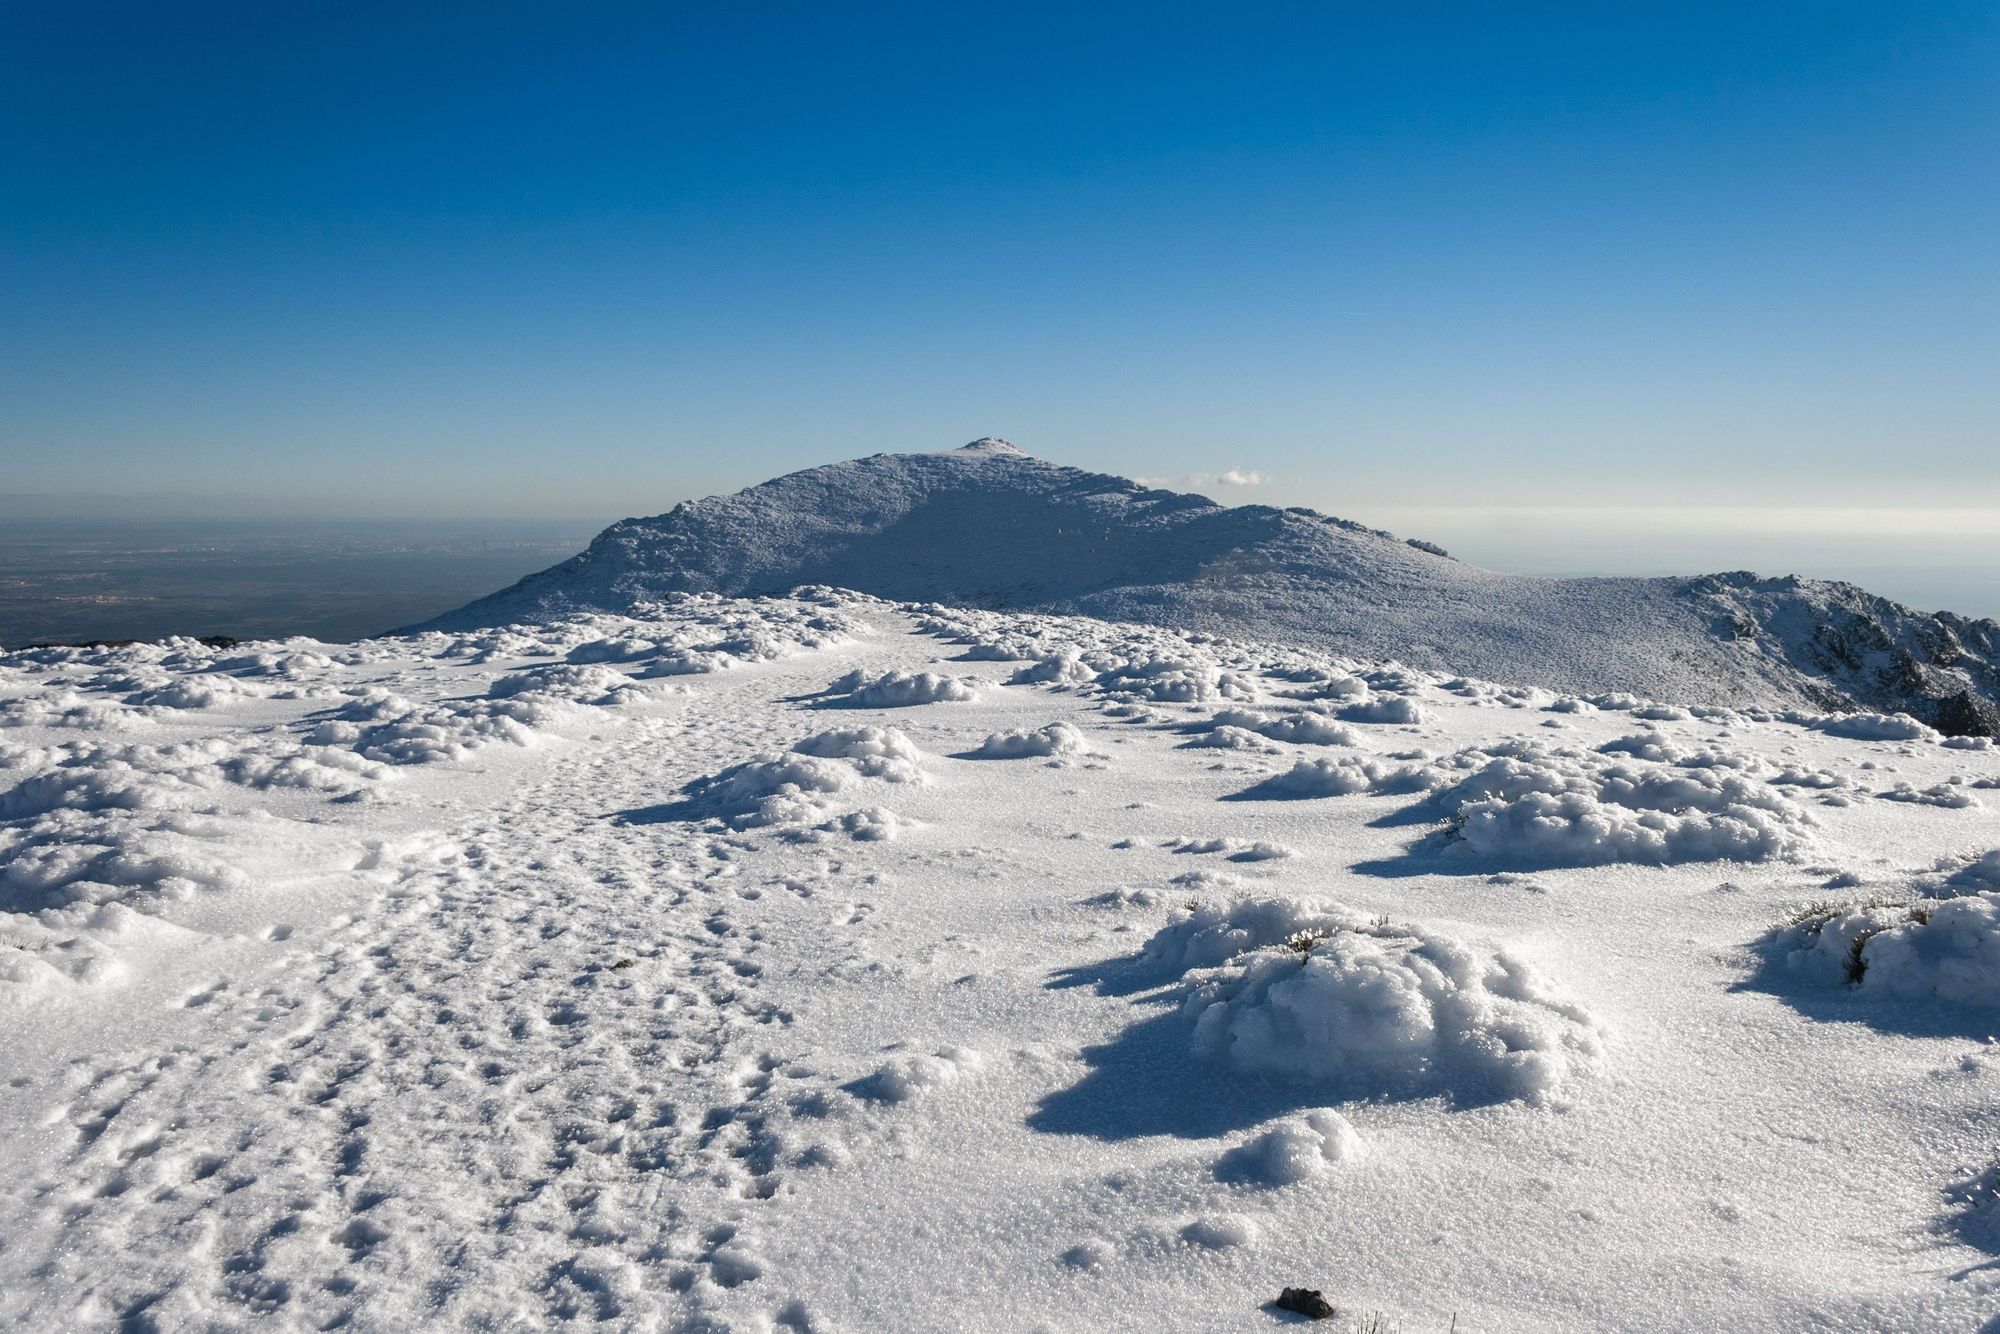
{"left": 8, "top": 708, "right": 824, "bottom": 1328}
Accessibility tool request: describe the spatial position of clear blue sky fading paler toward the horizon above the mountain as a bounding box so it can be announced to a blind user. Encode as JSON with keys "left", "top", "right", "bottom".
{"left": 0, "top": 0, "right": 2000, "bottom": 518}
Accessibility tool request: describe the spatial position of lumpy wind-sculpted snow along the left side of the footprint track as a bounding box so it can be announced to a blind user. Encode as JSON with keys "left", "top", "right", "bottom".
{"left": 0, "top": 594, "right": 852, "bottom": 994}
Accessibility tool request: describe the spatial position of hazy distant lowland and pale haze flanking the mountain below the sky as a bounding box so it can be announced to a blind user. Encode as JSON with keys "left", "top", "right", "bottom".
{"left": 0, "top": 482, "right": 2000, "bottom": 644}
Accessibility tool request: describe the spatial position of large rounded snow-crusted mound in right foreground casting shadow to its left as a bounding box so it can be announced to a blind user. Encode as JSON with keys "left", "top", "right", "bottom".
{"left": 1148, "top": 898, "right": 1600, "bottom": 1104}
